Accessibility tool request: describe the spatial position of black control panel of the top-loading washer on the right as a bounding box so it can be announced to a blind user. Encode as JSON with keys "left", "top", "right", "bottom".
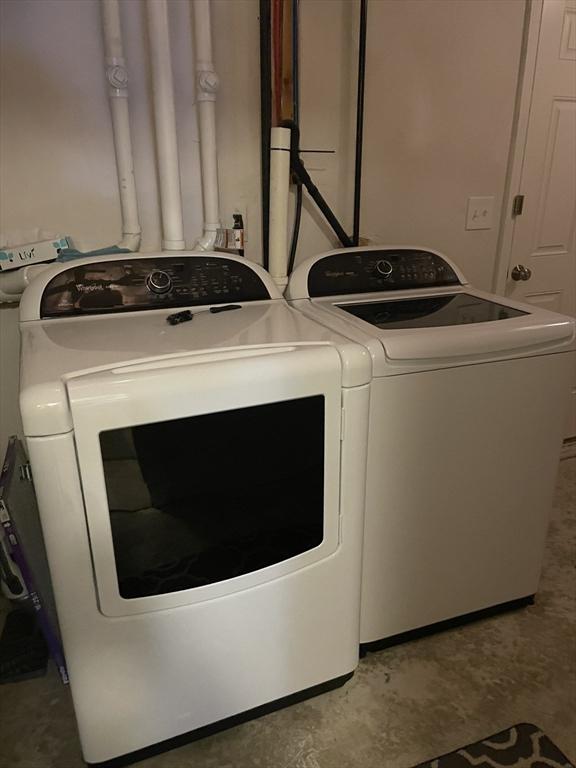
{"left": 308, "top": 248, "right": 460, "bottom": 297}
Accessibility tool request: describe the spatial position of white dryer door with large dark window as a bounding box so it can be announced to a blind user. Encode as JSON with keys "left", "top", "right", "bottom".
{"left": 67, "top": 345, "right": 341, "bottom": 616}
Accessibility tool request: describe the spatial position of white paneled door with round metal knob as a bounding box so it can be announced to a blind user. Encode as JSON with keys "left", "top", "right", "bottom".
{"left": 506, "top": 0, "right": 576, "bottom": 436}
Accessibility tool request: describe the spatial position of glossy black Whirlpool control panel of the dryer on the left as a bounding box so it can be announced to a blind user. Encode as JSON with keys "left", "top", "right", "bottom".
{"left": 40, "top": 255, "right": 270, "bottom": 318}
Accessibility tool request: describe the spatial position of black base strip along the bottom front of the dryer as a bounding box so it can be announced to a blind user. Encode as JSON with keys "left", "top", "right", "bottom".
{"left": 87, "top": 671, "right": 354, "bottom": 768}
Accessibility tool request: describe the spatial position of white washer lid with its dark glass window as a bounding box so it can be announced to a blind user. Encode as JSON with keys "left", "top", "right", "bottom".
{"left": 322, "top": 288, "right": 575, "bottom": 376}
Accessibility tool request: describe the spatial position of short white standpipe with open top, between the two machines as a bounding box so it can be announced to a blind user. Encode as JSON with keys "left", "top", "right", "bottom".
{"left": 269, "top": 128, "right": 290, "bottom": 290}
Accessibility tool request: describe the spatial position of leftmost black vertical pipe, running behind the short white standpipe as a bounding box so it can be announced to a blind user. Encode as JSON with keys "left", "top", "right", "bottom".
{"left": 260, "top": 0, "right": 272, "bottom": 269}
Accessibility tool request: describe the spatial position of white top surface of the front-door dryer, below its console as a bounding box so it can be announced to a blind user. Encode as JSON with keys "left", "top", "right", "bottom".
{"left": 20, "top": 299, "right": 371, "bottom": 436}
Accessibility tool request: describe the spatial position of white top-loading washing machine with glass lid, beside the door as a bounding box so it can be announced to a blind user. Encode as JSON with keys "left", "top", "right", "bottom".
{"left": 286, "top": 246, "right": 576, "bottom": 650}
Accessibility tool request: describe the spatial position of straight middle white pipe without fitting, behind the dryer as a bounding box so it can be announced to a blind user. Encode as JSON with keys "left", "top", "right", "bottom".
{"left": 147, "top": 0, "right": 184, "bottom": 251}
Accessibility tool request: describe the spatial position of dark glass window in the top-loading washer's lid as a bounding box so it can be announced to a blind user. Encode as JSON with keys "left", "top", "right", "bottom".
{"left": 337, "top": 293, "right": 527, "bottom": 328}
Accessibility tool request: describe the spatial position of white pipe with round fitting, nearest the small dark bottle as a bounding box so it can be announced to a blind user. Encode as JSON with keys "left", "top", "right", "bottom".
{"left": 192, "top": 0, "right": 220, "bottom": 251}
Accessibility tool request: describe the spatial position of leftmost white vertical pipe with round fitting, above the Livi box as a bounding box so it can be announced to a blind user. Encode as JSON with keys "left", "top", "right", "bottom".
{"left": 101, "top": 0, "right": 141, "bottom": 251}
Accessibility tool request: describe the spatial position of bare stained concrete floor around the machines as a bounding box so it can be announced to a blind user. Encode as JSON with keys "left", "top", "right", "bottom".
{"left": 0, "top": 458, "right": 576, "bottom": 768}
